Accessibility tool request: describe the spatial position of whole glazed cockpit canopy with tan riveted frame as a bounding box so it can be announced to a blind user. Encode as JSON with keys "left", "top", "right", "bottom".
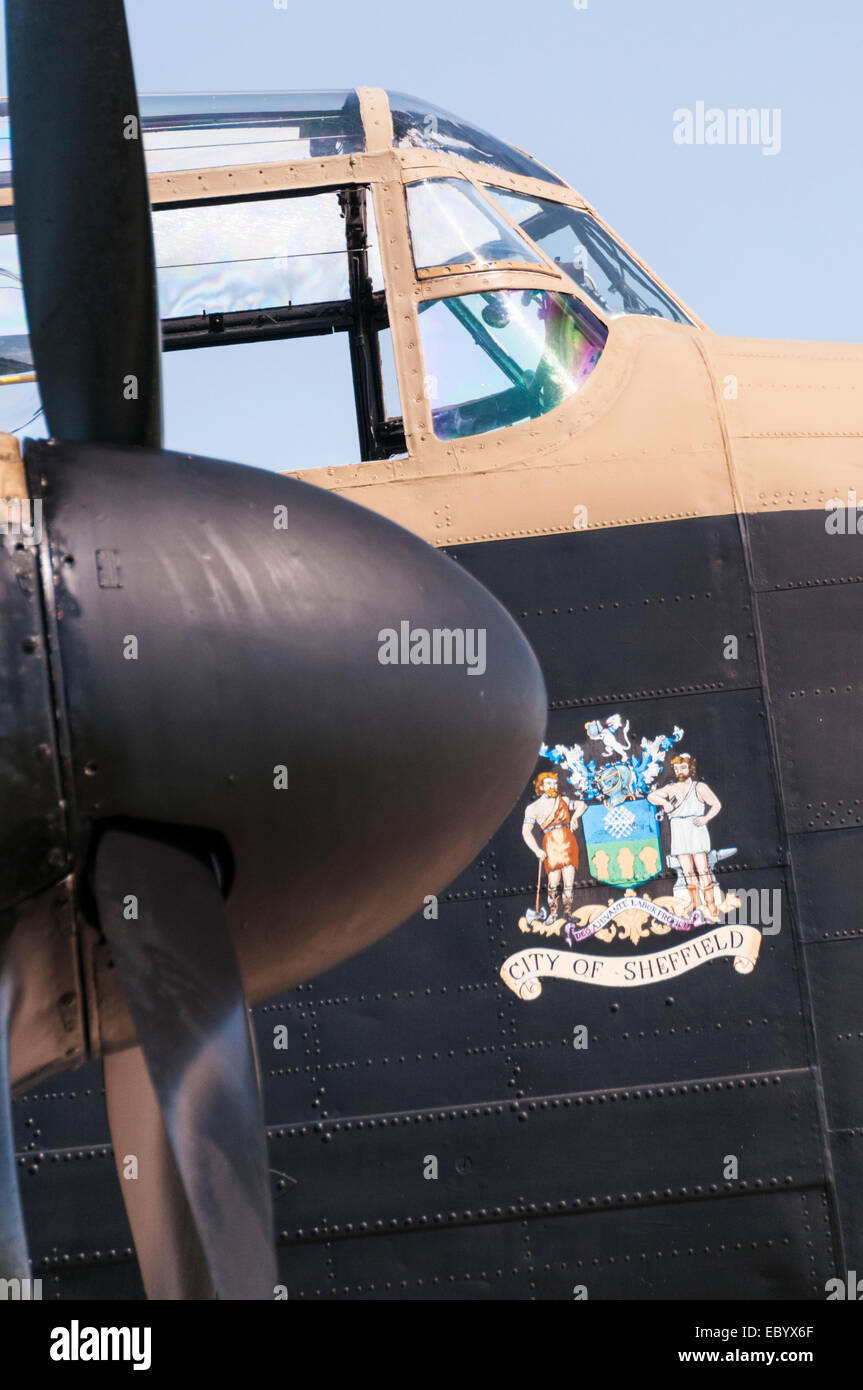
{"left": 0, "top": 88, "right": 693, "bottom": 468}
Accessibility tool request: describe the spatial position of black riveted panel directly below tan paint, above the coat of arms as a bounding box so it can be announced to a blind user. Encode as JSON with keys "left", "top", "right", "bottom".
{"left": 449, "top": 514, "right": 757, "bottom": 709}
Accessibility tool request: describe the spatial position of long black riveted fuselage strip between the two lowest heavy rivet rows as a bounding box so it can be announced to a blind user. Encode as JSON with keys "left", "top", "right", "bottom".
{"left": 264, "top": 1070, "right": 824, "bottom": 1245}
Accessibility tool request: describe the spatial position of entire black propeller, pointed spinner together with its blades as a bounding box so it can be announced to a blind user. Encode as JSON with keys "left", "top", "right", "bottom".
{"left": 0, "top": 0, "right": 546, "bottom": 1298}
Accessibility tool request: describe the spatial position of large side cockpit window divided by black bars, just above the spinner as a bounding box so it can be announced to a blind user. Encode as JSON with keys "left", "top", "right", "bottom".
{"left": 153, "top": 186, "right": 404, "bottom": 470}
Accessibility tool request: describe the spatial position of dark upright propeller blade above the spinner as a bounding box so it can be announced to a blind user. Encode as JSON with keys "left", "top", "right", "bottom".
{"left": 6, "top": 0, "right": 161, "bottom": 446}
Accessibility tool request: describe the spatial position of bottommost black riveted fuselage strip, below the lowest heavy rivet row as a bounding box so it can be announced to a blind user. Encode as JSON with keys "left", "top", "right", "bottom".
{"left": 279, "top": 1188, "right": 835, "bottom": 1301}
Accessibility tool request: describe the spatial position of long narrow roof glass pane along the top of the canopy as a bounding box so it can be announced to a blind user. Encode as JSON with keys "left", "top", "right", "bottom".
{"left": 139, "top": 92, "right": 364, "bottom": 174}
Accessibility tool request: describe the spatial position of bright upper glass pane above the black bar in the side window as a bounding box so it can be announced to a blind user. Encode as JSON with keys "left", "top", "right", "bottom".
{"left": 153, "top": 192, "right": 349, "bottom": 318}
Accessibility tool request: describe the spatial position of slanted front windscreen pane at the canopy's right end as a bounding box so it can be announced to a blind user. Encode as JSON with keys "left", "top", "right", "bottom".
{"left": 488, "top": 188, "right": 692, "bottom": 324}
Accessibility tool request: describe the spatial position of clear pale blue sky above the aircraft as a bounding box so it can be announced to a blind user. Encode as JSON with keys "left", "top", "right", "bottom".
{"left": 3, "top": 0, "right": 863, "bottom": 466}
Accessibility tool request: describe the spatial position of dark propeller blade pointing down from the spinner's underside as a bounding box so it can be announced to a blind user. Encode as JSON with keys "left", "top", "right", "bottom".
{"left": 94, "top": 828, "right": 275, "bottom": 1298}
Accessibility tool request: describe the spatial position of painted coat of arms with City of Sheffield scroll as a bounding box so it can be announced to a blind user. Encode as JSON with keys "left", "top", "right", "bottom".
{"left": 500, "top": 714, "right": 760, "bottom": 999}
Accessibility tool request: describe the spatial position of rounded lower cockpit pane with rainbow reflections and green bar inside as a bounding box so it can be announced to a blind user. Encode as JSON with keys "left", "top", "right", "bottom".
{"left": 418, "top": 289, "right": 607, "bottom": 439}
